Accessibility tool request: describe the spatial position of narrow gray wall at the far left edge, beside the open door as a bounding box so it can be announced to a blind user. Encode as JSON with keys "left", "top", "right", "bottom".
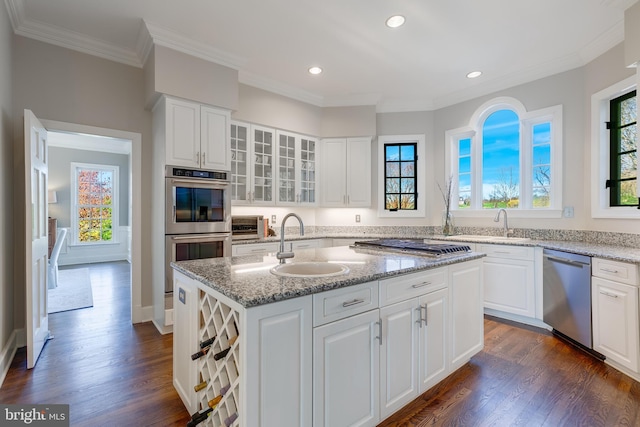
{"left": 0, "top": 0, "right": 14, "bottom": 372}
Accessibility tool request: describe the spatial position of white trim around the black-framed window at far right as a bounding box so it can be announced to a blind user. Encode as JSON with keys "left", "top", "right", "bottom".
{"left": 591, "top": 76, "right": 640, "bottom": 219}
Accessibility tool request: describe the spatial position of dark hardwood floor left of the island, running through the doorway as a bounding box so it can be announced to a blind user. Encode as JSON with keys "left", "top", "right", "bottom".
{"left": 0, "top": 262, "right": 190, "bottom": 426}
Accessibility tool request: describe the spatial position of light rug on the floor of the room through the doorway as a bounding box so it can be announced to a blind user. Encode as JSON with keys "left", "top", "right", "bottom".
{"left": 47, "top": 268, "right": 93, "bottom": 313}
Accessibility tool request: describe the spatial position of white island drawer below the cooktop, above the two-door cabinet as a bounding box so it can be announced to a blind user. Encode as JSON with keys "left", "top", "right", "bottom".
{"left": 380, "top": 268, "right": 447, "bottom": 306}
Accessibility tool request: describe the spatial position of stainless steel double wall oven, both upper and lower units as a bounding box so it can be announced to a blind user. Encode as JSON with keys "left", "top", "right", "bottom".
{"left": 165, "top": 166, "right": 231, "bottom": 292}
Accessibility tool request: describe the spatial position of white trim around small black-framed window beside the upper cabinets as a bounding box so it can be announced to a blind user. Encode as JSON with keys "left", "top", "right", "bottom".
{"left": 376, "top": 134, "right": 433, "bottom": 218}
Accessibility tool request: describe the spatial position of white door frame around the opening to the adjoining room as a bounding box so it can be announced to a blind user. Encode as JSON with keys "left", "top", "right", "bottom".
{"left": 40, "top": 119, "right": 143, "bottom": 323}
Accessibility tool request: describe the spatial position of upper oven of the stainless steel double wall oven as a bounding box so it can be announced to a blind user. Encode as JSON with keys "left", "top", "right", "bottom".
{"left": 165, "top": 166, "right": 231, "bottom": 234}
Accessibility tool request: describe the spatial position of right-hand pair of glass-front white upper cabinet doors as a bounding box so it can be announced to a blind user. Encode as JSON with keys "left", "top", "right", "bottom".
{"left": 276, "top": 131, "right": 318, "bottom": 206}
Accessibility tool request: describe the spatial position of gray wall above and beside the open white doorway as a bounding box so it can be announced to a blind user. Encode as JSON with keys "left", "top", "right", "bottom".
{"left": 12, "top": 35, "right": 152, "bottom": 334}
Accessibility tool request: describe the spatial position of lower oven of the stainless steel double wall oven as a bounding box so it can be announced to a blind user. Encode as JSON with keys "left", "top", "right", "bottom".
{"left": 164, "top": 233, "right": 231, "bottom": 292}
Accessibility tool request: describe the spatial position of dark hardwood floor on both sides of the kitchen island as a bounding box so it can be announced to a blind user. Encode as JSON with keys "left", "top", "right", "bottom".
{"left": 0, "top": 263, "right": 640, "bottom": 427}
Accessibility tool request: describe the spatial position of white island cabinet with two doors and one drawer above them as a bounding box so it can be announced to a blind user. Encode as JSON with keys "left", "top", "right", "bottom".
{"left": 380, "top": 268, "right": 449, "bottom": 419}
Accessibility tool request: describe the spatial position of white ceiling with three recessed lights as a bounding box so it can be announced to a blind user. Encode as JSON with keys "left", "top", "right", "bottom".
{"left": 5, "top": 0, "right": 637, "bottom": 112}
